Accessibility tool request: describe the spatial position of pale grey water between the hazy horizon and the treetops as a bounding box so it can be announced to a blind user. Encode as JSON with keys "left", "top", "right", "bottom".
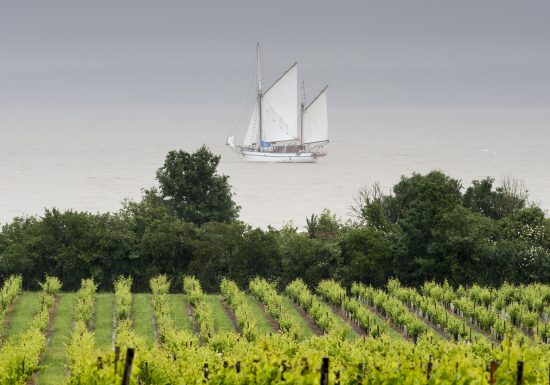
{"left": 0, "top": 106, "right": 550, "bottom": 227}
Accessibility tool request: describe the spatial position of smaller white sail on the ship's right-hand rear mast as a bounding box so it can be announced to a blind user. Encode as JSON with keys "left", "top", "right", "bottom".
{"left": 302, "top": 87, "right": 328, "bottom": 143}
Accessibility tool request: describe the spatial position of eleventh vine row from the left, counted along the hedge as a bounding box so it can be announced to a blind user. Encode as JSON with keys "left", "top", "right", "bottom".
{"left": 351, "top": 283, "right": 428, "bottom": 341}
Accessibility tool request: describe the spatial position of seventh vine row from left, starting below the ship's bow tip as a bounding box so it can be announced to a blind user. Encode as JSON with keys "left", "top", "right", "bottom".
{"left": 220, "top": 278, "right": 260, "bottom": 341}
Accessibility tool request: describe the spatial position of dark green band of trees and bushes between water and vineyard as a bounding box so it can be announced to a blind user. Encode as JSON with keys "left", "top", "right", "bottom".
{"left": 0, "top": 146, "right": 550, "bottom": 291}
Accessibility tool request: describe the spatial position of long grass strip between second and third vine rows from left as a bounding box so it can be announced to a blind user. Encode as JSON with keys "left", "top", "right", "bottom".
{"left": 38, "top": 293, "right": 76, "bottom": 385}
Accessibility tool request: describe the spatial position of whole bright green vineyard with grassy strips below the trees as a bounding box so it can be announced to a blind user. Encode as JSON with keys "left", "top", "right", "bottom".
{"left": 0, "top": 275, "right": 550, "bottom": 385}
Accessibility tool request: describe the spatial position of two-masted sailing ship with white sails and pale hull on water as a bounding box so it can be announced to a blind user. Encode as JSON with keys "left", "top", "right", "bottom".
{"left": 226, "top": 44, "right": 329, "bottom": 163}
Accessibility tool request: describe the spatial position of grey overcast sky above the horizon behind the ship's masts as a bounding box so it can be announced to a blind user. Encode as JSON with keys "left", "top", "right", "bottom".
{"left": 0, "top": 0, "right": 550, "bottom": 106}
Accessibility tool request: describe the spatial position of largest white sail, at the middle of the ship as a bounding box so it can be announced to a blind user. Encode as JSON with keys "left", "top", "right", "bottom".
{"left": 261, "top": 64, "right": 298, "bottom": 142}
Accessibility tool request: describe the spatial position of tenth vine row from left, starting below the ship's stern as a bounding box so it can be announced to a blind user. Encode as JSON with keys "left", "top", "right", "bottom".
{"left": 317, "top": 280, "right": 388, "bottom": 337}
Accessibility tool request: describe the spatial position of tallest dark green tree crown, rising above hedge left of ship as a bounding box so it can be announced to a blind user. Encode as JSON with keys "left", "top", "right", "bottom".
{"left": 157, "top": 146, "right": 239, "bottom": 226}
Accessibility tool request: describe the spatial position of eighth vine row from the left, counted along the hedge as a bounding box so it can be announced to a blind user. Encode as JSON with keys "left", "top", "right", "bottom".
{"left": 248, "top": 278, "right": 300, "bottom": 339}
